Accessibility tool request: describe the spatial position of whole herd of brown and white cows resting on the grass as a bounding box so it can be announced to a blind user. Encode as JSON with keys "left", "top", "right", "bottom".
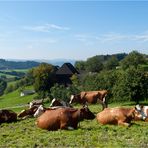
{"left": 0, "top": 90, "right": 148, "bottom": 130}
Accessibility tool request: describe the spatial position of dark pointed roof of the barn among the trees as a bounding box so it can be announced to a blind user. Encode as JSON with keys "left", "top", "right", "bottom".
{"left": 56, "top": 63, "right": 79, "bottom": 75}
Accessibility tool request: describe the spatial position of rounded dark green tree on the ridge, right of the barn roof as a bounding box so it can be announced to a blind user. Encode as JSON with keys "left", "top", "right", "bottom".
{"left": 86, "top": 56, "right": 103, "bottom": 72}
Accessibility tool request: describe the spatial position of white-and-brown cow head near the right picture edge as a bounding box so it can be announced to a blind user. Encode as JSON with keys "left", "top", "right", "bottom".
{"left": 135, "top": 104, "right": 147, "bottom": 120}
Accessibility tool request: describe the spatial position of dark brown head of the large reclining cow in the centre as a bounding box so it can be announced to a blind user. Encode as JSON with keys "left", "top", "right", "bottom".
{"left": 80, "top": 106, "right": 95, "bottom": 120}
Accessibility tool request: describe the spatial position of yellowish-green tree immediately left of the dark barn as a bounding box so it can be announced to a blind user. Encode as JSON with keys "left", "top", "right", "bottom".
{"left": 33, "top": 63, "right": 55, "bottom": 99}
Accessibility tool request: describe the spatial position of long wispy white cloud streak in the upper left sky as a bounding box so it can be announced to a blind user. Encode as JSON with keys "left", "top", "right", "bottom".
{"left": 23, "top": 24, "right": 70, "bottom": 32}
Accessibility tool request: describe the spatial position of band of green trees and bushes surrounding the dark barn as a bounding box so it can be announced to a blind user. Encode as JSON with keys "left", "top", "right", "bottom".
{"left": 0, "top": 51, "right": 148, "bottom": 103}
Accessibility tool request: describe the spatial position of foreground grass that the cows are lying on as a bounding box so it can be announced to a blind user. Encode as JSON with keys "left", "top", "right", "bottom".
{"left": 0, "top": 103, "right": 148, "bottom": 148}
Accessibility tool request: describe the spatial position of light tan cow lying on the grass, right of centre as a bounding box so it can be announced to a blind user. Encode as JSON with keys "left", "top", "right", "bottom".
{"left": 97, "top": 107, "right": 135, "bottom": 126}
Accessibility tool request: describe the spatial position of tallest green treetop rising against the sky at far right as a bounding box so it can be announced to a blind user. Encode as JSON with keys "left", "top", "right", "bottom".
{"left": 121, "top": 51, "right": 146, "bottom": 69}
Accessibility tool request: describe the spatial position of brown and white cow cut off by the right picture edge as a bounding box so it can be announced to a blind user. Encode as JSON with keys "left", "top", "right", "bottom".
{"left": 134, "top": 105, "right": 148, "bottom": 122}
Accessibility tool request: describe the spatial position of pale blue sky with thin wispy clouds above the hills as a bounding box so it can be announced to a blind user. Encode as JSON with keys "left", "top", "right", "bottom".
{"left": 0, "top": 0, "right": 148, "bottom": 60}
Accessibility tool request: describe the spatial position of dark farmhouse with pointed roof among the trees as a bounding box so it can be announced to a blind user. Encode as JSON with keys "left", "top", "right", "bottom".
{"left": 56, "top": 63, "right": 79, "bottom": 86}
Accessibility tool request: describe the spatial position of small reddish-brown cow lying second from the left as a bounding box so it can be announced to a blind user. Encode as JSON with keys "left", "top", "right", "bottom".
{"left": 18, "top": 106, "right": 38, "bottom": 119}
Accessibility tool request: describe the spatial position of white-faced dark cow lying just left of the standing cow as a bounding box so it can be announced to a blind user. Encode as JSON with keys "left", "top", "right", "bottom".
{"left": 50, "top": 98, "right": 72, "bottom": 107}
